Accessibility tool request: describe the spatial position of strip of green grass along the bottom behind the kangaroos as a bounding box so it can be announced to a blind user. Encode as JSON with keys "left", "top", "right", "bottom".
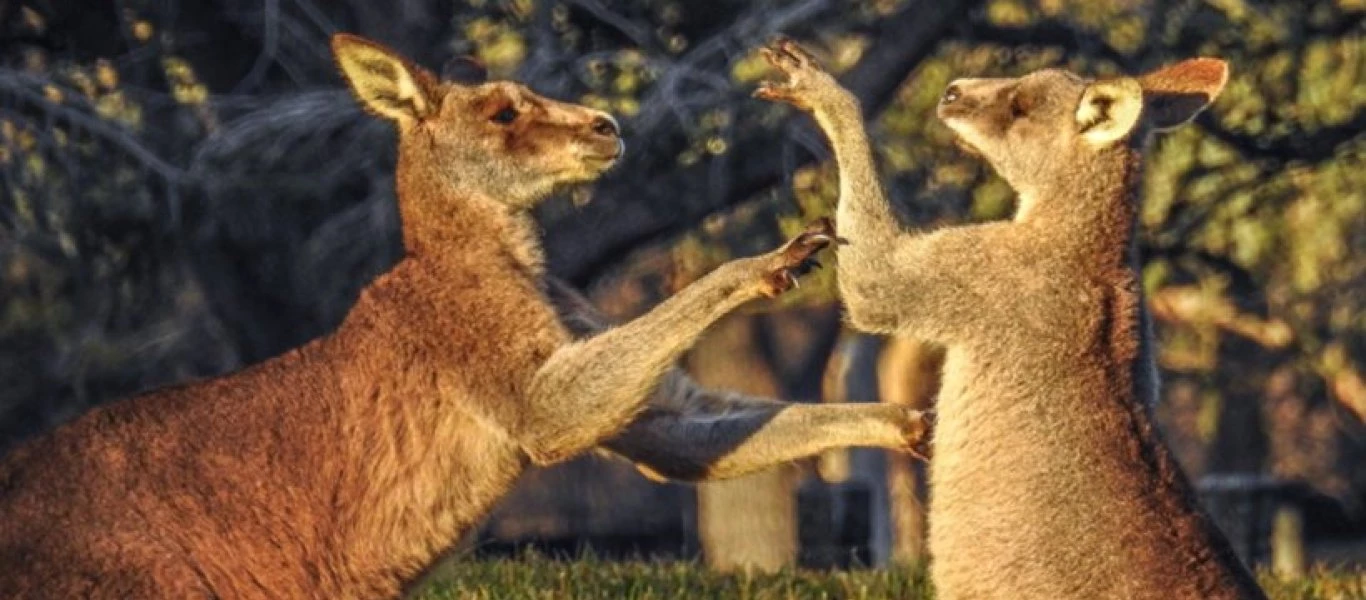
{"left": 415, "top": 555, "right": 1366, "bottom": 600}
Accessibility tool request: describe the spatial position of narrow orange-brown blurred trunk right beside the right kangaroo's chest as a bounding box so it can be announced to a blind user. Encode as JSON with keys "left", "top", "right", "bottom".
{"left": 877, "top": 338, "right": 944, "bottom": 564}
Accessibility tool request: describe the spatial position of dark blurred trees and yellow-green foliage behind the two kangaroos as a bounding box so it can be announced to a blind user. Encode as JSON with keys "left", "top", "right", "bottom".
{"left": 0, "top": 0, "right": 1366, "bottom": 574}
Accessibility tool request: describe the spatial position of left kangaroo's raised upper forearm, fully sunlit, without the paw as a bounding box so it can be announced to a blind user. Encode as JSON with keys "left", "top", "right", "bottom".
{"left": 514, "top": 261, "right": 754, "bottom": 463}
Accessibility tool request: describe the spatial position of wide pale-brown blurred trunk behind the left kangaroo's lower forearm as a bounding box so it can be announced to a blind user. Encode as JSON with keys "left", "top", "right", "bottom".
{"left": 687, "top": 314, "right": 796, "bottom": 571}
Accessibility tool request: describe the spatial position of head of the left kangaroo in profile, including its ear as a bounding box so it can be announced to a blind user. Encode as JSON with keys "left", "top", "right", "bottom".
{"left": 332, "top": 34, "right": 624, "bottom": 208}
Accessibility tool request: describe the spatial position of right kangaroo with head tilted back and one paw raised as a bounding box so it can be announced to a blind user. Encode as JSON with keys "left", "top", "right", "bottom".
{"left": 759, "top": 42, "right": 1264, "bottom": 600}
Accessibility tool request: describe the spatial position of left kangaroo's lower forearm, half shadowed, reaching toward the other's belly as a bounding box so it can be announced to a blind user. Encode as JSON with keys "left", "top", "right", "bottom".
{"left": 605, "top": 400, "right": 912, "bottom": 481}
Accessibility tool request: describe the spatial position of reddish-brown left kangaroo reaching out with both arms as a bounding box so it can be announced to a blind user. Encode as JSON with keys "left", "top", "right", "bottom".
{"left": 0, "top": 36, "right": 922, "bottom": 599}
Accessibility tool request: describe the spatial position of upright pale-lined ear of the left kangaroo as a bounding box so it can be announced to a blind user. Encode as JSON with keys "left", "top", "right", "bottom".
{"left": 332, "top": 33, "right": 437, "bottom": 123}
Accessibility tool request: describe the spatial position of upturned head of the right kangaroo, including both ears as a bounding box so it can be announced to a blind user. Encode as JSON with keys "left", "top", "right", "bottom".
{"left": 938, "top": 59, "right": 1228, "bottom": 193}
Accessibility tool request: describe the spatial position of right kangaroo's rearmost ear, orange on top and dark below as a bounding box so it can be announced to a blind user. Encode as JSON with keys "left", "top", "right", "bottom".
{"left": 1138, "top": 59, "right": 1228, "bottom": 130}
